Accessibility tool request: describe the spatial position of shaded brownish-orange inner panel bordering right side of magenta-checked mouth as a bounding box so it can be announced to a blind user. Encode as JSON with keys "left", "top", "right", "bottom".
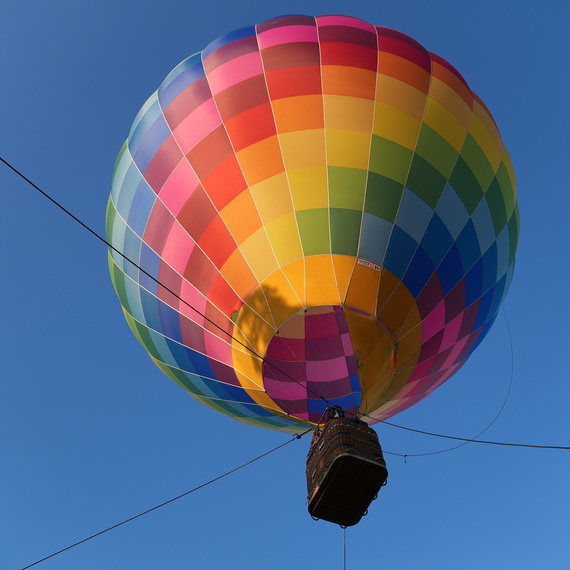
{"left": 345, "top": 309, "right": 396, "bottom": 410}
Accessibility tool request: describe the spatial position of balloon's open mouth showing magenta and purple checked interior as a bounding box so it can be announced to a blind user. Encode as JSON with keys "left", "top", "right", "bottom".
{"left": 262, "top": 305, "right": 361, "bottom": 423}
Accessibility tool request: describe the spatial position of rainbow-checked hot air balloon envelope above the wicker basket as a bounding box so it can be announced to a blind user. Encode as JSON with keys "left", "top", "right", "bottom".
{"left": 107, "top": 16, "right": 519, "bottom": 431}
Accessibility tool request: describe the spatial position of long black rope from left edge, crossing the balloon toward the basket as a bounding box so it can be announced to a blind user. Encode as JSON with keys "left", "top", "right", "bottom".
{"left": 0, "top": 156, "right": 329, "bottom": 404}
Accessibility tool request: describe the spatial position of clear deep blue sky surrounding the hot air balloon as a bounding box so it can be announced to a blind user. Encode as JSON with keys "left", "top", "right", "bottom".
{"left": 0, "top": 0, "right": 570, "bottom": 570}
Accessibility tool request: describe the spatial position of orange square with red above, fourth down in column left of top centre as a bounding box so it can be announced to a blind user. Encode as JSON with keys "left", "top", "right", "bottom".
{"left": 271, "top": 95, "right": 324, "bottom": 133}
